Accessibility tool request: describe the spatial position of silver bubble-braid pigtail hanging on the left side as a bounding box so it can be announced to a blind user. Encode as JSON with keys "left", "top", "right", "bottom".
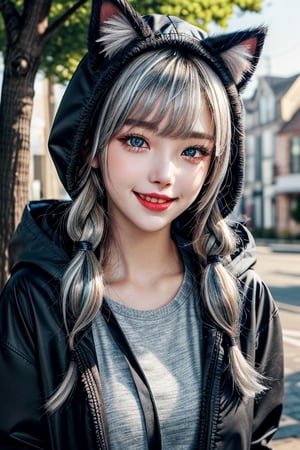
{"left": 46, "top": 171, "right": 105, "bottom": 411}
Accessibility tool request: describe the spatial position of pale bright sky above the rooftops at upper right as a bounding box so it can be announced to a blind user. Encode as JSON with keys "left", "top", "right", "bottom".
{"left": 218, "top": 0, "right": 300, "bottom": 77}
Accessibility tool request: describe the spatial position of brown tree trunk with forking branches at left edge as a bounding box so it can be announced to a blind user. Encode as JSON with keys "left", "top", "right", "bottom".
{"left": 0, "top": 0, "right": 87, "bottom": 290}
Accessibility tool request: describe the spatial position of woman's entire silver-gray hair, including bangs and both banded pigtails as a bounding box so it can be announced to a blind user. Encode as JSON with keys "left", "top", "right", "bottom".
{"left": 47, "top": 48, "right": 263, "bottom": 410}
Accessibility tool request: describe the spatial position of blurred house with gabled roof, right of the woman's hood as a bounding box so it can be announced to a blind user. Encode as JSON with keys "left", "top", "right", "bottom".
{"left": 241, "top": 74, "right": 300, "bottom": 236}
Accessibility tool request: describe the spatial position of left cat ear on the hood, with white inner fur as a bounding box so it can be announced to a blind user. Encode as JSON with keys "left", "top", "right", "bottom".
{"left": 88, "top": 0, "right": 153, "bottom": 66}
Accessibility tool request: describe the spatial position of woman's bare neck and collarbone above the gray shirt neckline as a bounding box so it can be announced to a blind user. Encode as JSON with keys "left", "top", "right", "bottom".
{"left": 104, "top": 225, "right": 184, "bottom": 310}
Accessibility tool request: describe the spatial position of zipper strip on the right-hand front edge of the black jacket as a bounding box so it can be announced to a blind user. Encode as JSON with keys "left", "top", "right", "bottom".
{"left": 199, "top": 331, "right": 223, "bottom": 450}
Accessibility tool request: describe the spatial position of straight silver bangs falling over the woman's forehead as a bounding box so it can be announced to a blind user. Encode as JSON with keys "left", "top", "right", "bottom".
{"left": 125, "top": 55, "right": 210, "bottom": 138}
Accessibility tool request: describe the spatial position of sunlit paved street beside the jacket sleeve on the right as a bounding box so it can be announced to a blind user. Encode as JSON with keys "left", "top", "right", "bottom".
{"left": 256, "top": 247, "right": 300, "bottom": 450}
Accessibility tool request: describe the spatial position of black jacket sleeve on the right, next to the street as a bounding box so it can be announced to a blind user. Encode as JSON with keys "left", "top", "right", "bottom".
{"left": 241, "top": 270, "right": 284, "bottom": 450}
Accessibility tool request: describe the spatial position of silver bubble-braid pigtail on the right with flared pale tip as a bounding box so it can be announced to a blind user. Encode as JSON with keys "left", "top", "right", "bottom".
{"left": 194, "top": 209, "right": 266, "bottom": 397}
